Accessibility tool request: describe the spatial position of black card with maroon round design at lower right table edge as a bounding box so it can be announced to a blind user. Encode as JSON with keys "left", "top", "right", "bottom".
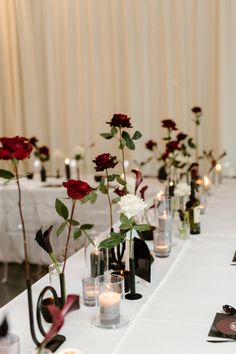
{"left": 208, "top": 312, "right": 236, "bottom": 340}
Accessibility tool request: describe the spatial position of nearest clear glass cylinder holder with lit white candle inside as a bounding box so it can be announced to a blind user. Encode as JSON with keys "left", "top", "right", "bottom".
{"left": 93, "top": 274, "right": 128, "bottom": 329}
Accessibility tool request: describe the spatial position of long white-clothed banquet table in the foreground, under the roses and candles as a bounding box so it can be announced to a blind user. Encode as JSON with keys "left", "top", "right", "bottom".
{"left": 0, "top": 180, "right": 236, "bottom": 354}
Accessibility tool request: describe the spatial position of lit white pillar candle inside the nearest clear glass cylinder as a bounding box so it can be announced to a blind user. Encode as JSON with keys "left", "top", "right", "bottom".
{"left": 98, "top": 291, "right": 121, "bottom": 326}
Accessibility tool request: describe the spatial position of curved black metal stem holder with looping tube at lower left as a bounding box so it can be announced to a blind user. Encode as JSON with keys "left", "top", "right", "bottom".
{"left": 26, "top": 274, "right": 66, "bottom": 352}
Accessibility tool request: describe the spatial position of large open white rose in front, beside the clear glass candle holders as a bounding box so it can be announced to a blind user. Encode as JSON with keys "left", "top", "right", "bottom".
{"left": 118, "top": 194, "right": 147, "bottom": 219}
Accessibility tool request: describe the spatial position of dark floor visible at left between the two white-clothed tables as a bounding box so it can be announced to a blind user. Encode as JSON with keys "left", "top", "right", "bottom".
{"left": 0, "top": 263, "right": 48, "bottom": 307}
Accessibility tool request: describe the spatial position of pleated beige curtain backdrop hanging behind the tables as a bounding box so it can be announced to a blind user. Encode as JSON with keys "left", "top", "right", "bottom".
{"left": 0, "top": 0, "right": 236, "bottom": 174}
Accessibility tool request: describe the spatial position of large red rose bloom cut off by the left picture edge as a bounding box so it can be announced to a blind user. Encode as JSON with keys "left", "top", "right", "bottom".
{"left": 0, "top": 136, "right": 33, "bottom": 160}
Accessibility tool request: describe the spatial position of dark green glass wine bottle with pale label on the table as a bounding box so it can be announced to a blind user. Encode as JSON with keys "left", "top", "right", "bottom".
{"left": 186, "top": 181, "right": 201, "bottom": 235}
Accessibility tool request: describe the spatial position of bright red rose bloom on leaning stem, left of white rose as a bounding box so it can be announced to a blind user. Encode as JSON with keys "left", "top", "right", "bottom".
{"left": 63, "top": 179, "right": 93, "bottom": 200}
